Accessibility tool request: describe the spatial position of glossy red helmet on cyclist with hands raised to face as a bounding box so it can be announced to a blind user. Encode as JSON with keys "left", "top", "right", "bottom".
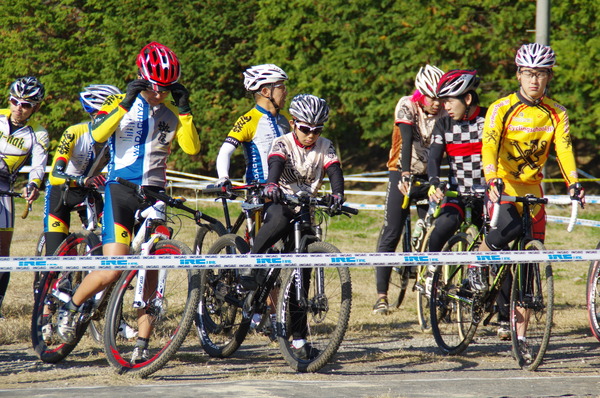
{"left": 137, "top": 41, "right": 181, "bottom": 90}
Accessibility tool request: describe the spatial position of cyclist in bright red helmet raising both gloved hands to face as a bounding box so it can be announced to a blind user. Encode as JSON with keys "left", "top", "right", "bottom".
{"left": 57, "top": 42, "right": 200, "bottom": 363}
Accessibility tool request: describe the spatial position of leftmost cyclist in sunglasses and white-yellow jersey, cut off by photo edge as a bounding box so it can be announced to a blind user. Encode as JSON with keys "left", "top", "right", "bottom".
{"left": 0, "top": 76, "right": 49, "bottom": 317}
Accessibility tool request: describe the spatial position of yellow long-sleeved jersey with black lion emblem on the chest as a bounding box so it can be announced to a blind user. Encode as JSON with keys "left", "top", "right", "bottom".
{"left": 482, "top": 92, "right": 578, "bottom": 185}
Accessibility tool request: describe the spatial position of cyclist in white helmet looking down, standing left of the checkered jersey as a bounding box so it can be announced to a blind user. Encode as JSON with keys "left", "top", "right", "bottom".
{"left": 373, "top": 65, "right": 446, "bottom": 314}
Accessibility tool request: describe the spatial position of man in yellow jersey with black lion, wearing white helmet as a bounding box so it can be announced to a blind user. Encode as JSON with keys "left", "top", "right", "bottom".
{"left": 469, "top": 43, "right": 585, "bottom": 347}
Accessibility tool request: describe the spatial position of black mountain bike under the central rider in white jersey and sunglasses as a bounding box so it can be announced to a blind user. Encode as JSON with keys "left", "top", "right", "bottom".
{"left": 200, "top": 195, "right": 358, "bottom": 372}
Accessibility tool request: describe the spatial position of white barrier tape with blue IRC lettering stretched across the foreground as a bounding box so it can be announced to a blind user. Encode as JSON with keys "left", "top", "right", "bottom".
{"left": 0, "top": 250, "right": 600, "bottom": 271}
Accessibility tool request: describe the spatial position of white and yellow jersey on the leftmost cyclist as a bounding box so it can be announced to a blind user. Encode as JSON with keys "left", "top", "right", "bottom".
{"left": 0, "top": 109, "right": 49, "bottom": 187}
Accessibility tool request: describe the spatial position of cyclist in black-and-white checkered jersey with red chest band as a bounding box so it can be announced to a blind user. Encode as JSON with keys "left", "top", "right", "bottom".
{"left": 427, "top": 70, "right": 487, "bottom": 252}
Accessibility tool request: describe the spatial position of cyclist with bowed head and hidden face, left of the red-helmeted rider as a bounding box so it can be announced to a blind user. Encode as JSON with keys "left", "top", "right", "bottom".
{"left": 44, "top": 84, "right": 121, "bottom": 256}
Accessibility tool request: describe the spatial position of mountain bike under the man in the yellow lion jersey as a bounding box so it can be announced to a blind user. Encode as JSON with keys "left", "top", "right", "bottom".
{"left": 430, "top": 190, "right": 580, "bottom": 370}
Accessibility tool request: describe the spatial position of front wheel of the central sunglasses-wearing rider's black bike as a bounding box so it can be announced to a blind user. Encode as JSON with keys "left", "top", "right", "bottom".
{"left": 276, "top": 242, "right": 352, "bottom": 372}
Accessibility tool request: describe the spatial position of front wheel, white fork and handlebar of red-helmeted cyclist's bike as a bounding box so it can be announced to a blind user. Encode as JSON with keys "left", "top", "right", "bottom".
{"left": 104, "top": 178, "right": 225, "bottom": 377}
